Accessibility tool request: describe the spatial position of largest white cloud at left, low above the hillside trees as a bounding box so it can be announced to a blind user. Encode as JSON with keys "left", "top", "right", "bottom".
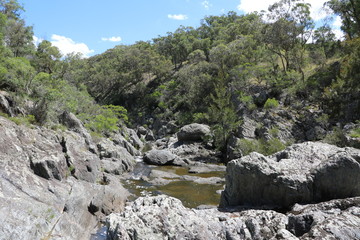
{"left": 51, "top": 34, "right": 94, "bottom": 58}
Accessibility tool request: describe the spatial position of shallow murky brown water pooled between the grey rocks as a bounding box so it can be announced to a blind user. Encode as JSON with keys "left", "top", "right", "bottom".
{"left": 123, "top": 163, "right": 225, "bottom": 208}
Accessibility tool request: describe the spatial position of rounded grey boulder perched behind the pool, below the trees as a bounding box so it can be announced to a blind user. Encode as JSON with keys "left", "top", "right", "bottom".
{"left": 177, "top": 123, "right": 211, "bottom": 142}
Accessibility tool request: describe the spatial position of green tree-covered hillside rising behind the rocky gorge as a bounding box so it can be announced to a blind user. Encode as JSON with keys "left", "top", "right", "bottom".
{"left": 0, "top": 0, "right": 360, "bottom": 159}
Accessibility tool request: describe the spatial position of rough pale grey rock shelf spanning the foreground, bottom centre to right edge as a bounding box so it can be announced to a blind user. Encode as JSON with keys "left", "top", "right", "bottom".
{"left": 106, "top": 195, "right": 360, "bottom": 240}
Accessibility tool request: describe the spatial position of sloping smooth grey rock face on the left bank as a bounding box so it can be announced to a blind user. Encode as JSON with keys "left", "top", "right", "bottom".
{"left": 0, "top": 117, "right": 134, "bottom": 239}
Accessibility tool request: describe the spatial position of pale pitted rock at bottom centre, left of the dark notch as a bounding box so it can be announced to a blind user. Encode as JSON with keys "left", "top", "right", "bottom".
{"left": 106, "top": 195, "right": 292, "bottom": 240}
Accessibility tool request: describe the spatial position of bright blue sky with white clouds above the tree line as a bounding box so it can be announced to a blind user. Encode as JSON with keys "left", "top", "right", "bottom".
{"left": 18, "top": 0, "right": 341, "bottom": 57}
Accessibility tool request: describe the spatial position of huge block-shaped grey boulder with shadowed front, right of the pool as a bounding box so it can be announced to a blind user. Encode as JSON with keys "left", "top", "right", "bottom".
{"left": 220, "top": 142, "right": 360, "bottom": 208}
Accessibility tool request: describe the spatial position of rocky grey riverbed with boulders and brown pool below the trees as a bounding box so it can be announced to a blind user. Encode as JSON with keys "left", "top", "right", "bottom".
{"left": 0, "top": 113, "right": 360, "bottom": 240}
